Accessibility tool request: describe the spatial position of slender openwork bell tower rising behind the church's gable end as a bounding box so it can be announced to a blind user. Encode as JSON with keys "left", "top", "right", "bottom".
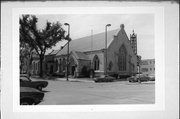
{"left": 130, "top": 30, "right": 137, "bottom": 54}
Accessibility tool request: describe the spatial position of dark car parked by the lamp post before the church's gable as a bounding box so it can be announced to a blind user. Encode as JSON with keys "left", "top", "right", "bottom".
{"left": 94, "top": 75, "right": 115, "bottom": 82}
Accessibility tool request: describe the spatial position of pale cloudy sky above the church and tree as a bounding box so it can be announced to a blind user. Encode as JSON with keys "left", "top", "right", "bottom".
{"left": 36, "top": 14, "right": 154, "bottom": 59}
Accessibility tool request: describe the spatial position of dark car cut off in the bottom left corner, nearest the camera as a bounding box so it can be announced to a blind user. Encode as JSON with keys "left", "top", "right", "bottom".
{"left": 20, "top": 87, "right": 44, "bottom": 105}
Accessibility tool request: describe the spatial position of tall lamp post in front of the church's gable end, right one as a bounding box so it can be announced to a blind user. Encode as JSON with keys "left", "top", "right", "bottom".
{"left": 105, "top": 24, "right": 111, "bottom": 75}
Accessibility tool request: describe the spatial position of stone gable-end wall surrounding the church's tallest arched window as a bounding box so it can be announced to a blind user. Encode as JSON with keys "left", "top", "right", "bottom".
{"left": 107, "top": 26, "right": 137, "bottom": 75}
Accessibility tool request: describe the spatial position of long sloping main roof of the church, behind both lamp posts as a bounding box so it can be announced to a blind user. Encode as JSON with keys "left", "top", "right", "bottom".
{"left": 56, "top": 29, "right": 120, "bottom": 56}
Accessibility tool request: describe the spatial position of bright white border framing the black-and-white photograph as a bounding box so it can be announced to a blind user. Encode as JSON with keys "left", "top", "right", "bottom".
{"left": 12, "top": 6, "right": 165, "bottom": 112}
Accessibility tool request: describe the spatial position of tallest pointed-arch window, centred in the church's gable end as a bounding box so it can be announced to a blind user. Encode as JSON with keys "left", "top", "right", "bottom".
{"left": 118, "top": 45, "right": 127, "bottom": 71}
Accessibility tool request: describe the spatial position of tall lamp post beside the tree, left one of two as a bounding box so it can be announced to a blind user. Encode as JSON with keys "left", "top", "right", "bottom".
{"left": 64, "top": 23, "right": 70, "bottom": 81}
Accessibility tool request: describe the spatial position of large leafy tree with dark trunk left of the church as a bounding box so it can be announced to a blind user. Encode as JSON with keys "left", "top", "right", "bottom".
{"left": 19, "top": 15, "right": 65, "bottom": 77}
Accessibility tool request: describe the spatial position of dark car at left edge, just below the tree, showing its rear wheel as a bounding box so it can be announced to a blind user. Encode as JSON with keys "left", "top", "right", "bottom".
{"left": 20, "top": 75, "right": 48, "bottom": 91}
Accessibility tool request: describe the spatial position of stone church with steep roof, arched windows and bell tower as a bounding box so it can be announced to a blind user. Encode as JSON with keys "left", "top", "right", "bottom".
{"left": 41, "top": 24, "right": 138, "bottom": 77}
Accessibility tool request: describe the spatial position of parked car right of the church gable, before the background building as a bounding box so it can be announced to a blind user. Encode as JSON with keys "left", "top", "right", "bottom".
{"left": 127, "top": 74, "right": 150, "bottom": 83}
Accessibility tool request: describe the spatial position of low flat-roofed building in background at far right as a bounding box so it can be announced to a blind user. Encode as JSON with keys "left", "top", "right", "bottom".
{"left": 141, "top": 59, "right": 155, "bottom": 76}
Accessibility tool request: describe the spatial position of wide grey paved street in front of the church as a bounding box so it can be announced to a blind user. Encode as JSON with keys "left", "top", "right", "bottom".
{"left": 36, "top": 79, "right": 155, "bottom": 105}
